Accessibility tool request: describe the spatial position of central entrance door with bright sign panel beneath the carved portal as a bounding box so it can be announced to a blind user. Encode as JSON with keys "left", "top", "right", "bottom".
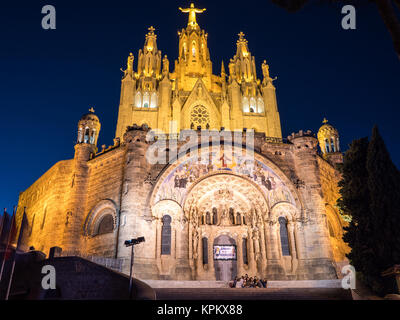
{"left": 213, "top": 235, "right": 237, "bottom": 281}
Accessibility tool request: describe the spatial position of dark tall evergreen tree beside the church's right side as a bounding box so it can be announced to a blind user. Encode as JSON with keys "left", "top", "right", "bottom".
{"left": 338, "top": 127, "right": 400, "bottom": 295}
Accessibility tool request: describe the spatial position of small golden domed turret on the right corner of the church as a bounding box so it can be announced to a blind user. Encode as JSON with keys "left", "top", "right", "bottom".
{"left": 318, "top": 118, "right": 343, "bottom": 163}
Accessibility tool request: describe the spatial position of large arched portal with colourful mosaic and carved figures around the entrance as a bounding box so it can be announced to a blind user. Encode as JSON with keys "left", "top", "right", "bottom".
{"left": 149, "top": 147, "right": 300, "bottom": 280}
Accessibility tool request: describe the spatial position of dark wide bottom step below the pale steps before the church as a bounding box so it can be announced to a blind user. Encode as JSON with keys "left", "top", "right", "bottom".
{"left": 155, "top": 288, "right": 352, "bottom": 300}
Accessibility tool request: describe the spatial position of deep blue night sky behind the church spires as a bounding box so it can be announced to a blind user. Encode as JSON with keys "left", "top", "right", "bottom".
{"left": 0, "top": 0, "right": 400, "bottom": 211}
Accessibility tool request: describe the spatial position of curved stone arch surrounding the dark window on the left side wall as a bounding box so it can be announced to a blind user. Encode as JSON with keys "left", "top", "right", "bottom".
{"left": 84, "top": 199, "right": 118, "bottom": 237}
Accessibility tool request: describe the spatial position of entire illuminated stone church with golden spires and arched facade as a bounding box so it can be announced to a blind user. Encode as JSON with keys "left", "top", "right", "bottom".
{"left": 17, "top": 5, "right": 347, "bottom": 280}
